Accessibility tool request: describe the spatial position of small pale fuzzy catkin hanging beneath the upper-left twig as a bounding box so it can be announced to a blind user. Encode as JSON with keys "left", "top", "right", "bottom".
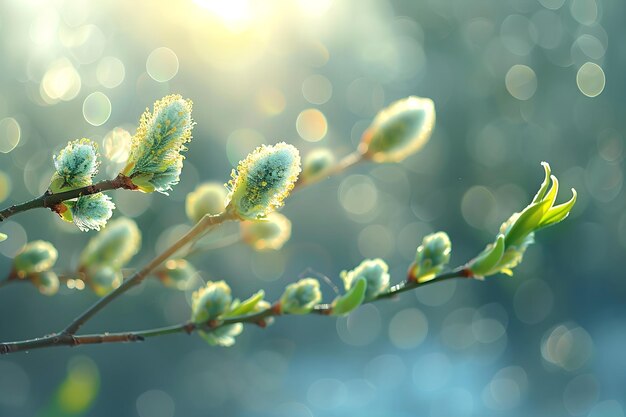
{"left": 66, "top": 193, "right": 115, "bottom": 232}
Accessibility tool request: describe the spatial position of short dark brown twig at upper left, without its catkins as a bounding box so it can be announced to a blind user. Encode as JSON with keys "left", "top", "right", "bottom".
{"left": 0, "top": 174, "right": 137, "bottom": 222}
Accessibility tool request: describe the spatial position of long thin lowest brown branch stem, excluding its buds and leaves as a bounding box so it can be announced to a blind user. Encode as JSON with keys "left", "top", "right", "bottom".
{"left": 0, "top": 268, "right": 470, "bottom": 354}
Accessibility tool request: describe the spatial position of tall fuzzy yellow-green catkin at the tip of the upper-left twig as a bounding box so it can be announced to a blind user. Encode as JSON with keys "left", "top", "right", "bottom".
{"left": 122, "top": 95, "right": 194, "bottom": 194}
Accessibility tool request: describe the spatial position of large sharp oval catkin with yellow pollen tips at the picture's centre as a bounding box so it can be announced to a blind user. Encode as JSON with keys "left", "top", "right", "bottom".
{"left": 226, "top": 142, "right": 300, "bottom": 220}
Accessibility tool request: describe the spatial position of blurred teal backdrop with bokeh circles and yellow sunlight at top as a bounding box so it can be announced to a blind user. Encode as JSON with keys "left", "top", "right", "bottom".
{"left": 0, "top": 0, "right": 626, "bottom": 417}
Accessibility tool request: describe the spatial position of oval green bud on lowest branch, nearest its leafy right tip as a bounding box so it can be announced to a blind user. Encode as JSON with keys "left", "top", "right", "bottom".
{"left": 410, "top": 232, "right": 452, "bottom": 282}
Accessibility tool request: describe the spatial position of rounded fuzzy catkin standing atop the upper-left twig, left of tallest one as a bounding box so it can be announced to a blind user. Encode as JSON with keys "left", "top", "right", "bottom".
{"left": 49, "top": 138, "right": 99, "bottom": 193}
